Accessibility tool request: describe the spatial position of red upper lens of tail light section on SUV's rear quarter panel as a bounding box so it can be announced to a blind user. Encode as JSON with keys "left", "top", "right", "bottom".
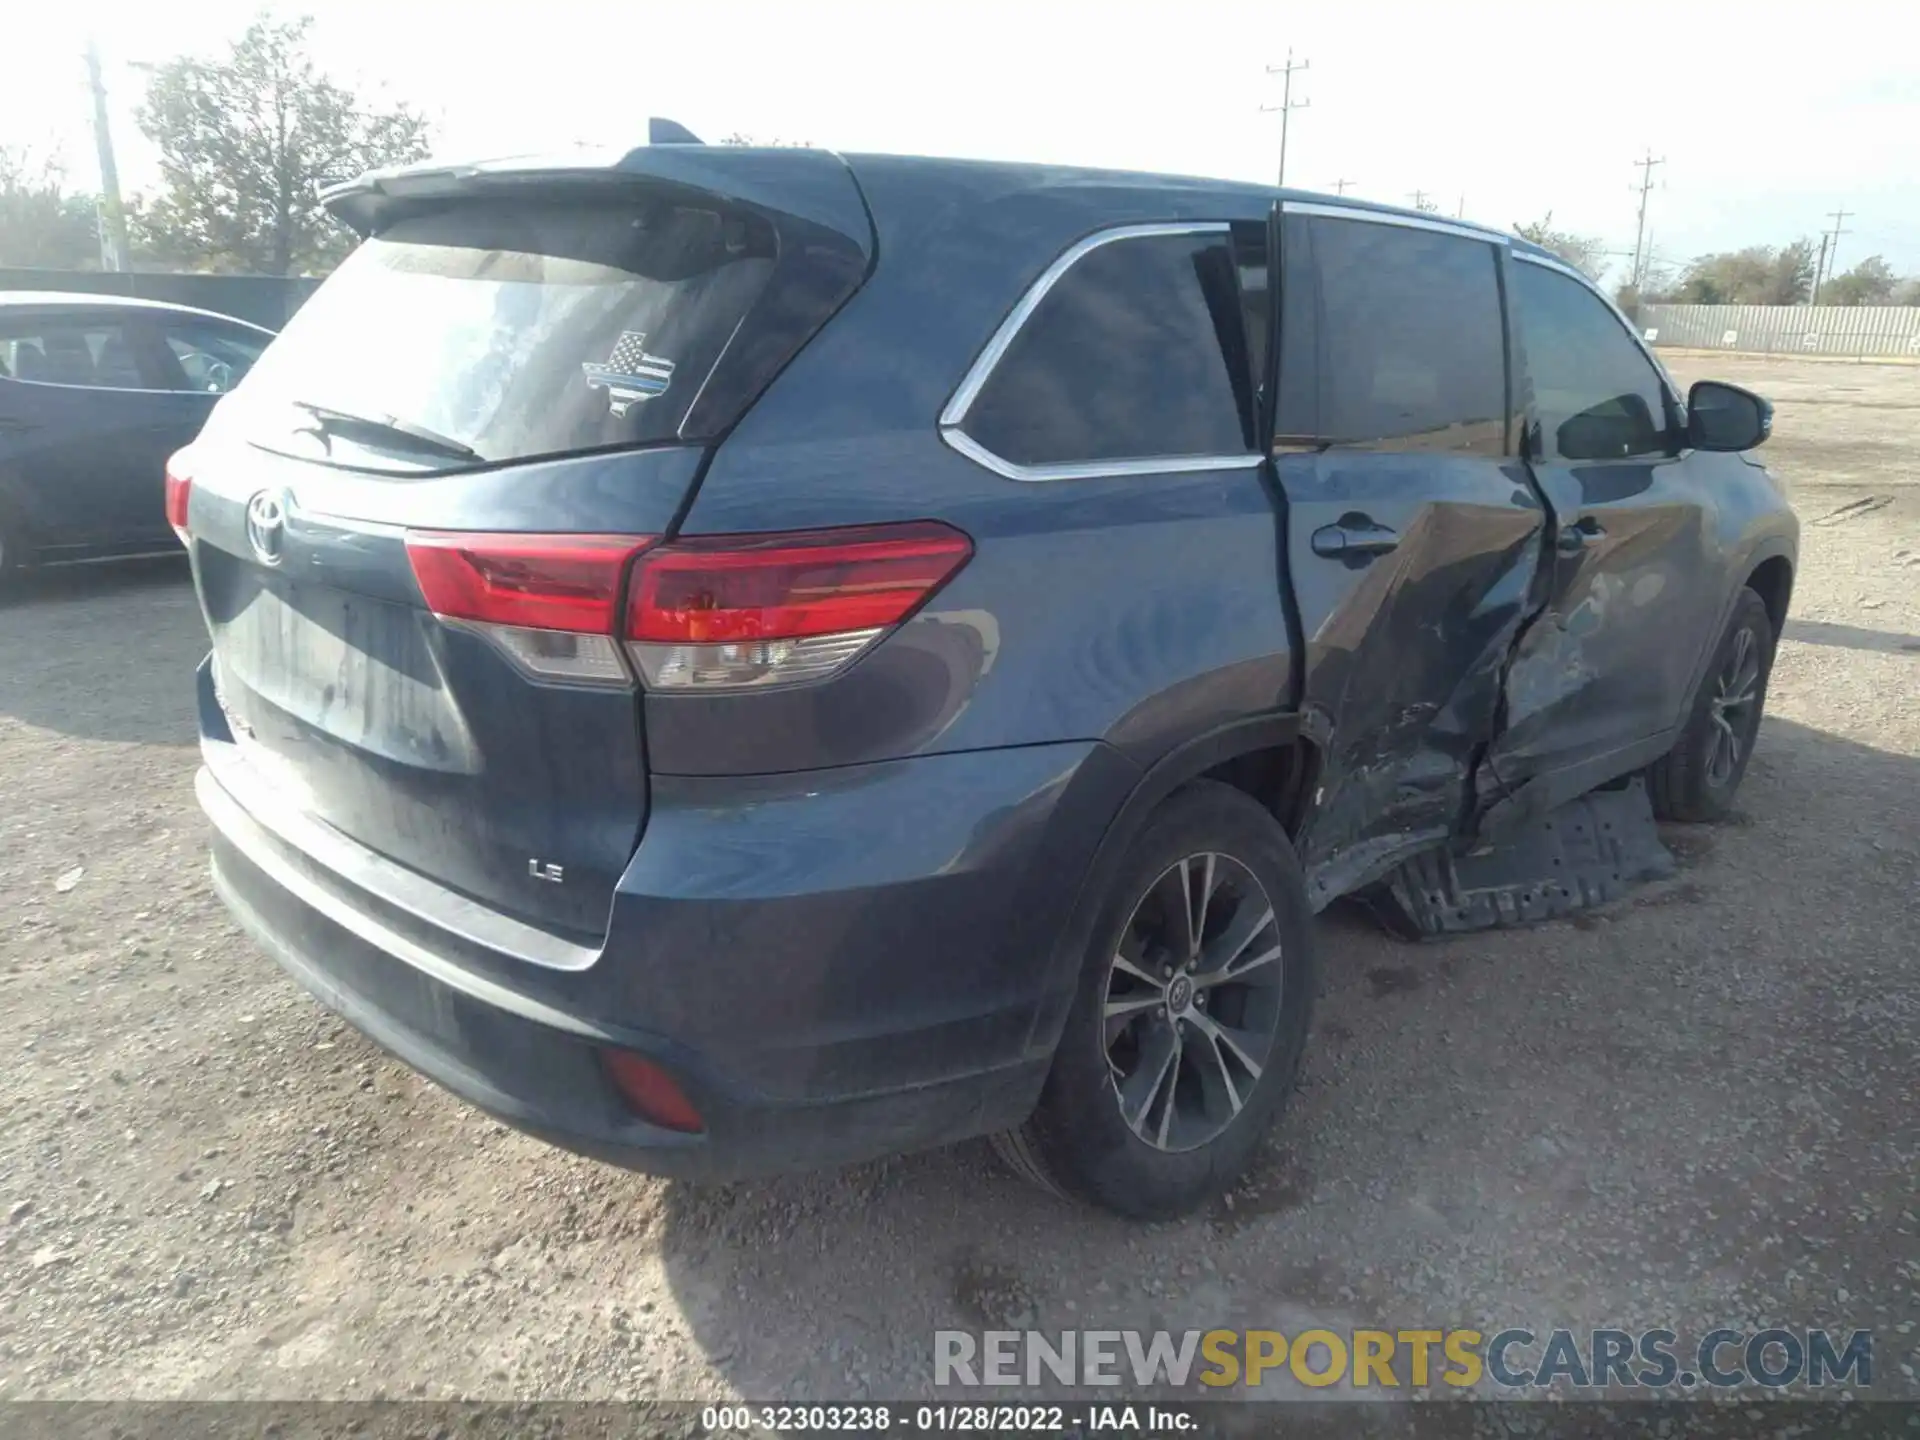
{"left": 626, "top": 520, "right": 973, "bottom": 645}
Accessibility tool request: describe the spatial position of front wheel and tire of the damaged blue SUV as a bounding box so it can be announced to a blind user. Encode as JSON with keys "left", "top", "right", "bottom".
{"left": 1647, "top": 589, "right": 1774, "bottom": 822}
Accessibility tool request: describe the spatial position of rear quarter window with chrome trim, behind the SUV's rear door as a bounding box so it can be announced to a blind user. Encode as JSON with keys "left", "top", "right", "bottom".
{"left": 962, "top": 230, "right": 1248, "bottom": 465}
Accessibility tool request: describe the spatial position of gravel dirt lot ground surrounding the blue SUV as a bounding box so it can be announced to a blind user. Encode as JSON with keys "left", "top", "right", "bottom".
{"left": 0, "top": 357, "right": 1920, "bottom": 1398}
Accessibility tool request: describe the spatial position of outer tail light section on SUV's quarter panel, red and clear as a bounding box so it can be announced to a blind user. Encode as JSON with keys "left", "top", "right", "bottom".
{"left": 626, "top": 520, "right": 973, "bottom": 691}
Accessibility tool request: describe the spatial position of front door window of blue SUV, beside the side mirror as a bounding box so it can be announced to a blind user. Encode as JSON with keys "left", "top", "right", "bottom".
{"left": 1511, "top": 263, "right": 1672, "bottom": 461}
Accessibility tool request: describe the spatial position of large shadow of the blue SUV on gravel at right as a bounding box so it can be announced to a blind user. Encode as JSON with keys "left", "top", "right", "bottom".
{"left": 660, "top": 720, "right": 1920, "bottom": 1400}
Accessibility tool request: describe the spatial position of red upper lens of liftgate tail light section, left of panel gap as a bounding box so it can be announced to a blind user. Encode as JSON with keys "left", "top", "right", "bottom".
{"left": 407, "top": 530, "right": 653, "bottom": 636}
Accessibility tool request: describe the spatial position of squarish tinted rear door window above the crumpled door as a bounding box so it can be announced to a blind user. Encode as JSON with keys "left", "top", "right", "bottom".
{"left": 1277, "top": 217, "right": 1507, "bottom": 455}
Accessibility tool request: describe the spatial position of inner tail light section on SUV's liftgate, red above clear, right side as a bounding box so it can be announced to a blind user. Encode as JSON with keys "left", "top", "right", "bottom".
{"left": 407, "top": 530, "right": 653, "bottom": 685}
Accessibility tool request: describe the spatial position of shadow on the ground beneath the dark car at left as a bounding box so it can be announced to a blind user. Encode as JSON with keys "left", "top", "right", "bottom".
{"left": 0, "top": 557, "right": 207, "bottom": 745}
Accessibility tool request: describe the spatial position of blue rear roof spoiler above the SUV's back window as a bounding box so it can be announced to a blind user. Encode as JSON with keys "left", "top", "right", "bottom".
{"left": 321, "top": 142, "right": 874, "bottom": 259}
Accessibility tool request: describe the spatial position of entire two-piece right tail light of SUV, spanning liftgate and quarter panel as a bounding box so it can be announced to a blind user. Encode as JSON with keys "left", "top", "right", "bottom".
{"left": 407, "top": 520, "right": 973, "bottom": 691}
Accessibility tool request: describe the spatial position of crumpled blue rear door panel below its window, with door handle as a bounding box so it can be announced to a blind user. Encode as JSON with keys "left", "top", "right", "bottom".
{"left": 1275, "top": 449, "right": 1546, "bottom": 904}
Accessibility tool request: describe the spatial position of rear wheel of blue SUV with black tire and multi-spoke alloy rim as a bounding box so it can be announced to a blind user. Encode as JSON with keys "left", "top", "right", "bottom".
{"left": 995, "top": 780, "right": 1317, "bottom": 1219}
